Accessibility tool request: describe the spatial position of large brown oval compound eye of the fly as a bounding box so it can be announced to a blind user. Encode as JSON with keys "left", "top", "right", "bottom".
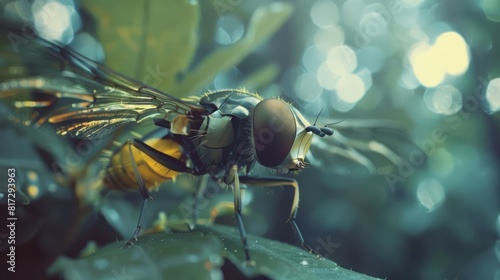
{"left": 252, "top": 99, "right": 297, "bottom": 167}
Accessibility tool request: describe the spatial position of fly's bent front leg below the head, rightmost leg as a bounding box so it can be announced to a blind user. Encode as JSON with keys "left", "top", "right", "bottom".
{"left": 239, "top": 176, "right": 313, "bottom": 253}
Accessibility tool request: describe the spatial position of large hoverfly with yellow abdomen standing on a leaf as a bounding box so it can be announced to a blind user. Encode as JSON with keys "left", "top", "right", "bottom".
{"left": 0, "top": 21, "right": 404, "bottom": 264}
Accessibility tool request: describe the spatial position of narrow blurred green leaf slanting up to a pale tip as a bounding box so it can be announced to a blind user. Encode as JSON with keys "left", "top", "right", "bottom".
{"left": 173, "top": 2, "right": 293, "bottom": 94}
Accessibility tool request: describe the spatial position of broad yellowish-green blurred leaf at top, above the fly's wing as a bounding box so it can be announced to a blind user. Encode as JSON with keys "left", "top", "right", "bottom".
{"left": 83, "top": 0, "right": 200, "bottom": 92}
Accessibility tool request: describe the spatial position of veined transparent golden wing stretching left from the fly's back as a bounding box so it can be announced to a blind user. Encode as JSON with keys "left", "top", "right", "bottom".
{"left": 0, "top": 22, "right": 205, "bottom": 139}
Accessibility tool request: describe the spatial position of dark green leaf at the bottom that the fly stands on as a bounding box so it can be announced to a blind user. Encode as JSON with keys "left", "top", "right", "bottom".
{"left": 49, "top": 225, "right": 382, "bottom": 280}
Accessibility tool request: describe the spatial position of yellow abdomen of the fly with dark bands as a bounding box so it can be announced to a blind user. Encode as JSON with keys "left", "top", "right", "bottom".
{"left": 104, "top": 138, "right": 182, "bottom": 190}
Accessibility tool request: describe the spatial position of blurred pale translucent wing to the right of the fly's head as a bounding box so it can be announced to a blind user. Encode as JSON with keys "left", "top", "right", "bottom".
{"left": 296, "top": 110, "right": 412, "bottom": 173}
